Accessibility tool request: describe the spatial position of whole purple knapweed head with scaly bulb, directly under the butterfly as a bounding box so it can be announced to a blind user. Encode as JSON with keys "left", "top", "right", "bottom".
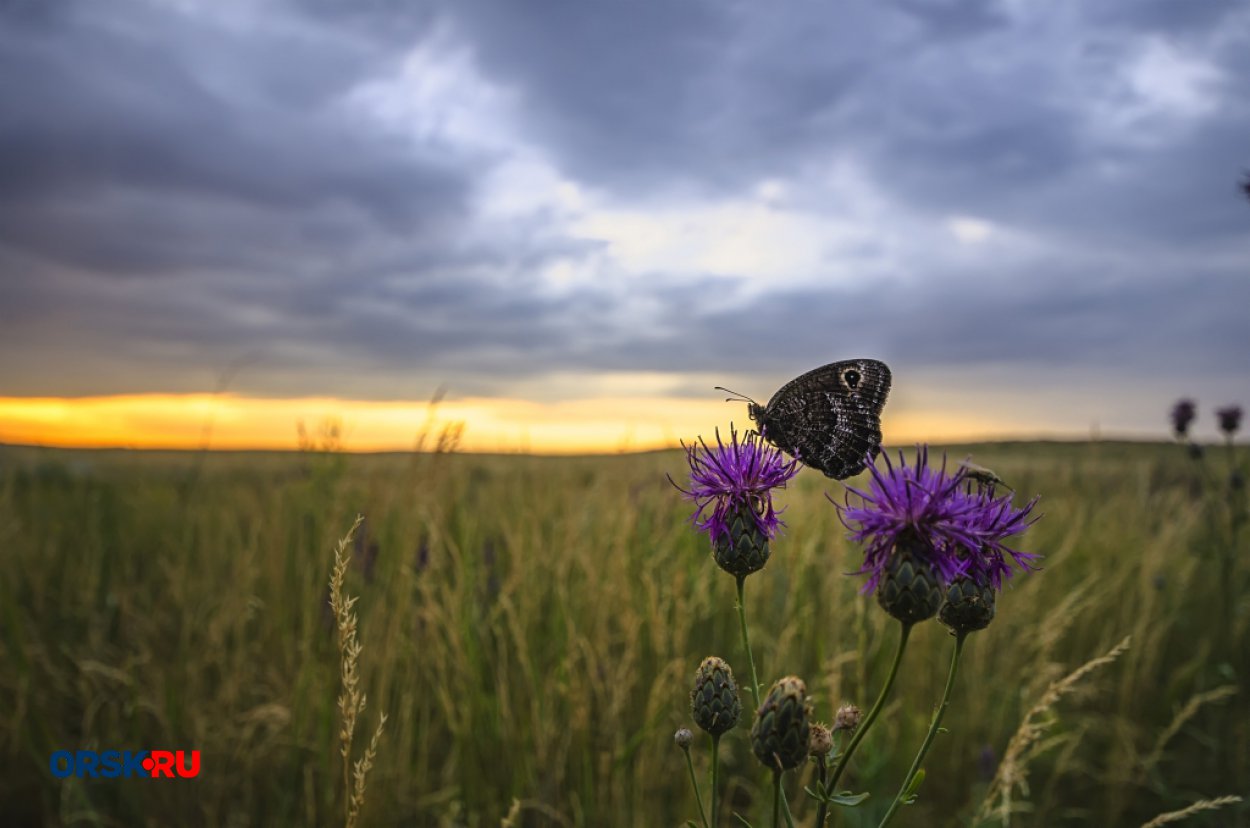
{"left": 670, "top": 425, "right": 799, "bottom": 577}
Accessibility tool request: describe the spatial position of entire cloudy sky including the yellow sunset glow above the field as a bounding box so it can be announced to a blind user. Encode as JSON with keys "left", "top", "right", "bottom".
{"left": 0, "top": 0, "right": 1250, "bottom": 452}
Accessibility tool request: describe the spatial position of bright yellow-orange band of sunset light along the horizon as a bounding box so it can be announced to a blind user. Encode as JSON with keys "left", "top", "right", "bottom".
{"left": 0, "top": 394, "right": 1040, "bottom": 454}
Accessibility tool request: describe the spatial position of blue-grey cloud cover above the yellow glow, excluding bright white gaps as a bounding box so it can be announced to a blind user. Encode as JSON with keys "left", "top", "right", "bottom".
{"left": 0, "top": 0, "right": 1250, "bottom": 422}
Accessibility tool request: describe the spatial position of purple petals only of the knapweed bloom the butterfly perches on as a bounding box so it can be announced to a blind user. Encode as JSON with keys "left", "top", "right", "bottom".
{"left": 669, "top": 425, "right": 799, "bottom": 544}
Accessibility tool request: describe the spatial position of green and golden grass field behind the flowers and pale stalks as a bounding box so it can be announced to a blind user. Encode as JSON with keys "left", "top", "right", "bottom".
{"left": 0, "top": 443, "right": 1250, "bottom": 828}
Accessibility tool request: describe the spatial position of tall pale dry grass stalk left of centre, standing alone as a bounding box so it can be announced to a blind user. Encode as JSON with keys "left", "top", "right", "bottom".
{"left": 330, "top": 515, "right": 386, "bottom": 828}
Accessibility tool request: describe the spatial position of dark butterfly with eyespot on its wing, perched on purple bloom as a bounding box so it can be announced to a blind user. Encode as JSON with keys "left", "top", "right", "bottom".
{"left": 720, "top": 359, "right": 890, "bottom": 480}
